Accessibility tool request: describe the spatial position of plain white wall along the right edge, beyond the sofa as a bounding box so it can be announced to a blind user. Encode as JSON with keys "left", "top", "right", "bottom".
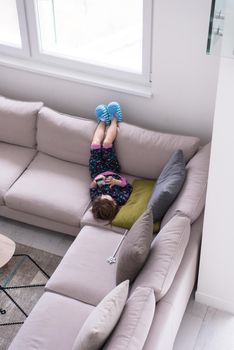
{"left": 196, "top": 59, "right": 234, "bottom": 313}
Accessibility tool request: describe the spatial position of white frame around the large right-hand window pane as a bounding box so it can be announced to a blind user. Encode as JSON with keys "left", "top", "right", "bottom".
{"left": 0, "top": 0, "right": 153, "bottom": 91}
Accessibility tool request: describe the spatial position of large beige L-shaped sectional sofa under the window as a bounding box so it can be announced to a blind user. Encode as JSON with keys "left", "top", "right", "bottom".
{"left": 0, "top": 97, "right": 210, "bottom": 350}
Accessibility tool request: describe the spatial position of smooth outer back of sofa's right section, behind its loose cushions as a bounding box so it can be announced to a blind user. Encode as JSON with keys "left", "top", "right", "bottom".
{"left": 140, "top": 215, "right": 203, "bottom": 350}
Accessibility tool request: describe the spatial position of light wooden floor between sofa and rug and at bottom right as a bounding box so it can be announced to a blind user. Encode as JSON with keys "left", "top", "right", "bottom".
{"left": 0, "top": 217, "right": 234, "bottom": 350}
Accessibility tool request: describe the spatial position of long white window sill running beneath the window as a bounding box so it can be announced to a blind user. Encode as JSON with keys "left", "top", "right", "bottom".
{"left": 0, "top": 55, "right": 152, "bottom": 98}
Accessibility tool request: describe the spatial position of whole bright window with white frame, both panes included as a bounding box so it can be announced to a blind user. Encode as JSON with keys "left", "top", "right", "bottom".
{"left": 0, "top": 0, "right": 152, "bottom": 90}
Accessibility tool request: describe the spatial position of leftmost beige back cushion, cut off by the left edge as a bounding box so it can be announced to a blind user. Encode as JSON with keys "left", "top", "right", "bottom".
{"left": 0, "top": 96, "right": 43, "bottom": 147}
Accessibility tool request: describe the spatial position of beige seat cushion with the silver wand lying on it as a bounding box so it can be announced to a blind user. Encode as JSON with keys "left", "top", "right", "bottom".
{"left": 46, "top": 226, "right": 122, "bottom": 305}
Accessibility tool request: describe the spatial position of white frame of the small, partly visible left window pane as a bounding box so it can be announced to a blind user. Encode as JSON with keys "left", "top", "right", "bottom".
{"left": 0, "top": 0, "right": 30, "bottom": 57}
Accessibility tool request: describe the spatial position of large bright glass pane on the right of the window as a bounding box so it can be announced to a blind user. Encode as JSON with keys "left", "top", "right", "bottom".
{"left": 36, "top": 0, "right": 143, "bottom": 73}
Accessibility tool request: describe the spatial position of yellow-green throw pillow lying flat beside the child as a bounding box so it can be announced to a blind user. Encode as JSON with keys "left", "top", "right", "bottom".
{"left": 112, "top": 180, "right": 159, "bottom": 232}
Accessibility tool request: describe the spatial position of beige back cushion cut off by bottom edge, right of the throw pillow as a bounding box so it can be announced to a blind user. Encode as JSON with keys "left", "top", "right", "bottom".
{"left": 103, "top": 287, "right": 155, "bottom": 350}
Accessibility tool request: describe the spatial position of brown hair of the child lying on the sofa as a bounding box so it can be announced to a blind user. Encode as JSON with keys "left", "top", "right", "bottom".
{"left": 92, "top": 196, "right": 119, "bottom": 222}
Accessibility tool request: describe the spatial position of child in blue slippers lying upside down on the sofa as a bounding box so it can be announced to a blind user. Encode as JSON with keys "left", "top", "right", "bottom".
{"left": 89, "top": 102, "right": 132, "bottom": 221}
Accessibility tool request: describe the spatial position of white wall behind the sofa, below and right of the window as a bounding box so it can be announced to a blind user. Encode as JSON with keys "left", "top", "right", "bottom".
{"left": 0, "top": 0, "right": 219, "bottom": 142}
